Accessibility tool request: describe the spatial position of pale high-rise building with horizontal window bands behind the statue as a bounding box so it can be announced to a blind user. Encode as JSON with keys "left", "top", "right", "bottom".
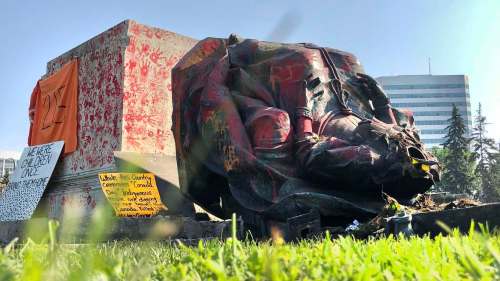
{"left": 377, "top": 75, "right": 472, "bottom": 147}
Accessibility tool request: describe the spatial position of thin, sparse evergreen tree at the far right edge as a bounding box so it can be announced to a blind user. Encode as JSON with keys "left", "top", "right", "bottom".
{"left": 472, "top": 104, "right": 500, "bottom": 201}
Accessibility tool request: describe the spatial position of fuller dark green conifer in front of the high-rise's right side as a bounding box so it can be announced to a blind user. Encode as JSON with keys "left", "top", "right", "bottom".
{"left": 438, "top": 105, "right": 478, "bottom": 197}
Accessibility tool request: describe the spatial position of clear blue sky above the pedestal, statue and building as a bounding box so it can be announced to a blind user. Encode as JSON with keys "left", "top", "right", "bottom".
{"left": 0, "top": 0, "right": 500, "bottom": 150}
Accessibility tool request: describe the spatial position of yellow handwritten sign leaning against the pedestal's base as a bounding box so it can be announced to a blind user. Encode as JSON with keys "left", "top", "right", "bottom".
{"left": 99, "top": 173, "right": 167, "bottom": 217}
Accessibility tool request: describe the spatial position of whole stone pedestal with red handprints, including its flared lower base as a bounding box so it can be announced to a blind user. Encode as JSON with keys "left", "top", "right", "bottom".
{"left": 37, "top": 20, "right": 197, "bottom": 218}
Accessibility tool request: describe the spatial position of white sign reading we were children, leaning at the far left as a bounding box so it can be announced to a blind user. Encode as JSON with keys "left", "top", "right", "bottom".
{"left": 0, "top": 141, "right": 64, "bottom": 221}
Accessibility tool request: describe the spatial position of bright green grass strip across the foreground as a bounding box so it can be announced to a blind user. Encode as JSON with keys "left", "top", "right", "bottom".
{"left": 0, "top": 226, "right": 500, "bottom": 280}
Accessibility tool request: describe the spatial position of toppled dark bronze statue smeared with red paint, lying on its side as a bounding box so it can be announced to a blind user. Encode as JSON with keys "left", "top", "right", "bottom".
{"left": 172, "top": 35, "right": 439, "bottom": 236}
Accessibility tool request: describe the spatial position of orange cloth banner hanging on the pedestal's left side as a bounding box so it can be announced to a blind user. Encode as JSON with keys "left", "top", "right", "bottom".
{"left": 28, "top": 59, "right": 78, "bottom": 154}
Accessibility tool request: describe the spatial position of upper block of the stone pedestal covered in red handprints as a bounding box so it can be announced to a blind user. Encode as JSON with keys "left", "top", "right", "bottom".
{"left": 42, "top": 21, "right": 195, "bottom": 174}
